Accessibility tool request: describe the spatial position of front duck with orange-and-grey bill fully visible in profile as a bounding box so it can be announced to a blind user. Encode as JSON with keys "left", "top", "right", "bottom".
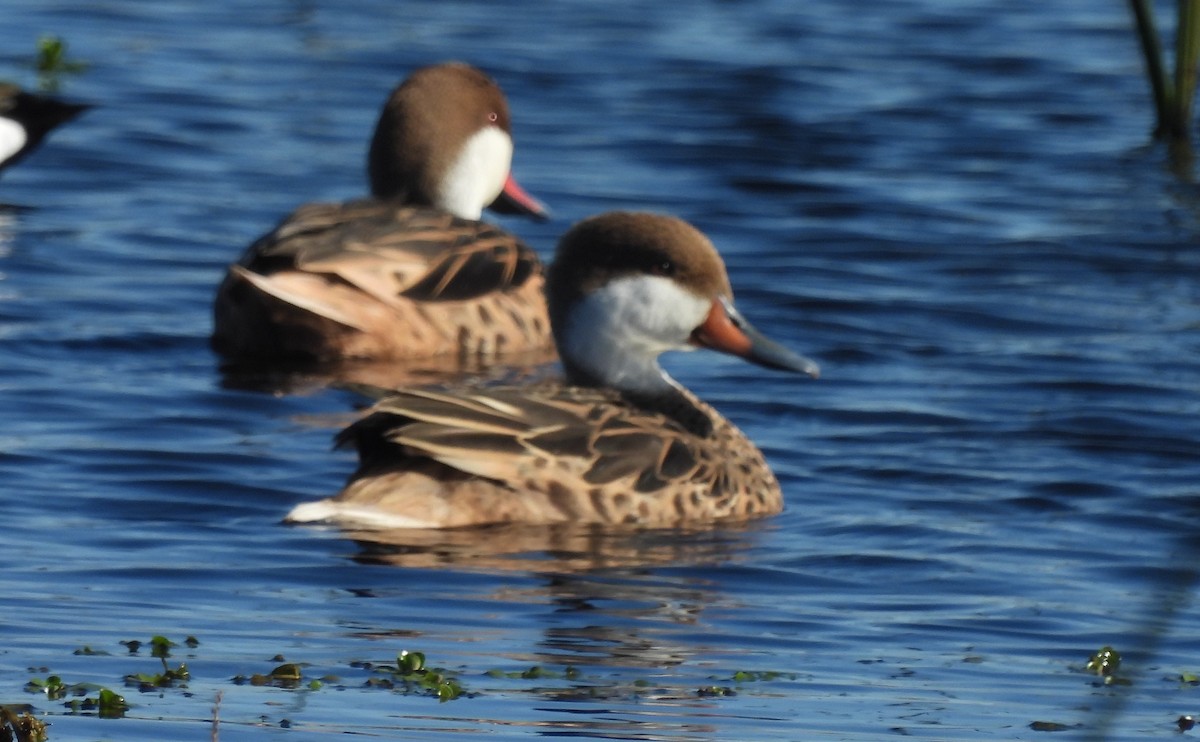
{"left": 284, "top": 211, "right": 820, "bottom": 532}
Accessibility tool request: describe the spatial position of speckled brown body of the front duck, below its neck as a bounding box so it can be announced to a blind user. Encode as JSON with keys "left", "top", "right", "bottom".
{"left": 282, "top": 360, "right": 782, "bottom": 527}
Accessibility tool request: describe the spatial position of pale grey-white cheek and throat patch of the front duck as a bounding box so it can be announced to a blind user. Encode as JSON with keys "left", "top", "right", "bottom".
{"left": 562, "top": 275, "right": 712, "bottom": 390}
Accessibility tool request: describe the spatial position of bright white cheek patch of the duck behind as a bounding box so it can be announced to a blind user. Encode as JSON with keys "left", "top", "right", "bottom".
{"left": 440, "top": 126, "right": 512, "bottom": 220}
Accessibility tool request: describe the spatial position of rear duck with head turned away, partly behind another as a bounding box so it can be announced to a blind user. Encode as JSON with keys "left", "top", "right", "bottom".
{"left": 211, "top": 62, "right": 552, "bottom": 363}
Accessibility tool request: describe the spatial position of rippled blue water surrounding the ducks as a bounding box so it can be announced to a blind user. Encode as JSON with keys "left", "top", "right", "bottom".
{"left": 0, "top": 0, "right": 1200, "bottom": 742}
